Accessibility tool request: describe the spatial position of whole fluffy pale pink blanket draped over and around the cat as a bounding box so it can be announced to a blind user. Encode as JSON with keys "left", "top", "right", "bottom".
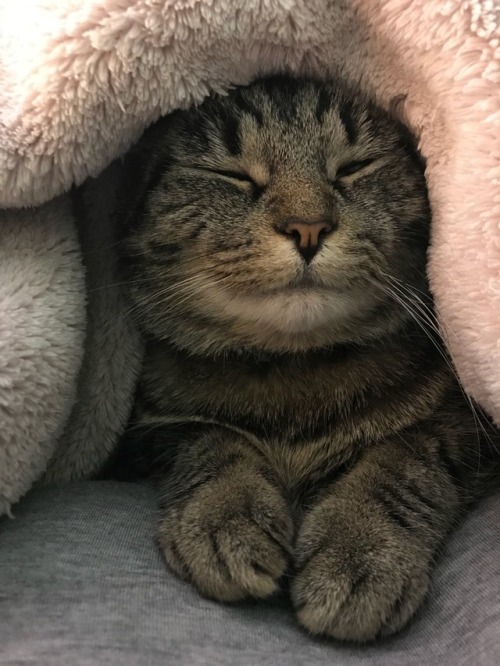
{"left": 0, "top": 0, "right": 500, "bottom": 513}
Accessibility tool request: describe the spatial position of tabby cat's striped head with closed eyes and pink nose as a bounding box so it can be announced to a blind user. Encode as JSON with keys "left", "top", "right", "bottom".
{"left": 123, "top": 77, "right": 429, "bottom": 351}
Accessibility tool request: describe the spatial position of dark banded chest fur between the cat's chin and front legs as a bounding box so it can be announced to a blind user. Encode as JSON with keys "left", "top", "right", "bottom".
{"left": 140, "top": 343, "right": 445, "bottom": 485}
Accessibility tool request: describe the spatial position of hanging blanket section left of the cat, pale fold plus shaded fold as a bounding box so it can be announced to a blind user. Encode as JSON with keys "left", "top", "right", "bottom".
{"left": 0, "top": 163, "right": 142, "bottom": 515}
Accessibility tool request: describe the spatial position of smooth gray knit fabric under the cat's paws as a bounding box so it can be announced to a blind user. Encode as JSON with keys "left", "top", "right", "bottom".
{"left": 0, "top": 482, "right": 500, "bottom": 666}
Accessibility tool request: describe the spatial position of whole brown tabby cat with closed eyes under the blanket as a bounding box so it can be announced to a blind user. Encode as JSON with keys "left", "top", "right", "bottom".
{"left": 114, "top": 75, "right": 498, "bottom": 641}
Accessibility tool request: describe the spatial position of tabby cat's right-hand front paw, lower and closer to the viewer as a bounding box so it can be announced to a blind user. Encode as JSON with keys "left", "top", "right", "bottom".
{"left": 292, "top": 502, "right": 432, "bottom": 642}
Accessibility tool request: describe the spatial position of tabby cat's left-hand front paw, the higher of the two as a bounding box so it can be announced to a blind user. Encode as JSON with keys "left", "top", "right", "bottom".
{"left": 160, "top": 478, "right": 293, "bottom": 601}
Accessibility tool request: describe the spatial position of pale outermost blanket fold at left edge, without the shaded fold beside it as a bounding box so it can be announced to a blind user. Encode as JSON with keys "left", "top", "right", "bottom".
{"left": 0, "top": 197, "right": 85, "bottom": 514}
